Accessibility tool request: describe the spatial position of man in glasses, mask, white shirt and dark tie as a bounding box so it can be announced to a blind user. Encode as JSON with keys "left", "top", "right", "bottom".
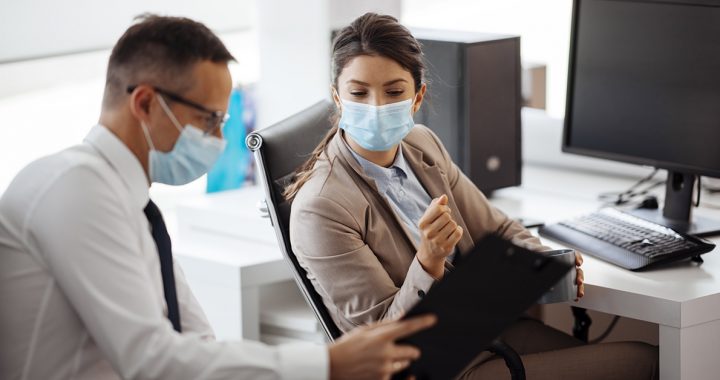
{"left": 0, "top": 15, "right": 434, "bottom": 379}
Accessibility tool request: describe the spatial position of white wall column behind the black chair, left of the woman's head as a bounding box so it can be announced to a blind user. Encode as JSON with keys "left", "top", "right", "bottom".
{"left": 253, "top": 0, "right": 401, "bottom": 128}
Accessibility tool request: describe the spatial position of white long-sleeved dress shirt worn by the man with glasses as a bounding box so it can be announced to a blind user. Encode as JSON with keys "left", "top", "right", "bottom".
{"left": 0, "top": 125, "right": 329, "bottom": 380}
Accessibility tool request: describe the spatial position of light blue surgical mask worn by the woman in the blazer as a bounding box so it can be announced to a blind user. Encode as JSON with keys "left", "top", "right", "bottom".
{"left": 339, "top": 99, "right": 415, "bottom": 151}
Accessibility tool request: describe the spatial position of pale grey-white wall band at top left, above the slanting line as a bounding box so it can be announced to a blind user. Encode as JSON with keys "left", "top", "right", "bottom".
{"left": 0, "top": 0, "right": 255, "bottom": 63}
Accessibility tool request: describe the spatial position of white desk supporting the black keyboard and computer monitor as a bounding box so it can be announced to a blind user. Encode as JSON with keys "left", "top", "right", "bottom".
{"left": 493, "top": 167, "right": 720, "bottom": 380}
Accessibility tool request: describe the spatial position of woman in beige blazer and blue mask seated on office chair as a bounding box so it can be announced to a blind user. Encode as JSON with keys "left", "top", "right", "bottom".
{"left": 285, "top": 13, "right": 657, "bottom": 379}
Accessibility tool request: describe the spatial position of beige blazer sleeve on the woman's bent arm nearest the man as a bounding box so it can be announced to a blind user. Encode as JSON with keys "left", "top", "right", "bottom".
{"left": 290, "top": 196, "right": 435, "bottom": 331}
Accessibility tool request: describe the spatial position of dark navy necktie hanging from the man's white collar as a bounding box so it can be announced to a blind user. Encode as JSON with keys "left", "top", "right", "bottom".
{"left": 144, "top": 200, "right": 182, "bottom": 332}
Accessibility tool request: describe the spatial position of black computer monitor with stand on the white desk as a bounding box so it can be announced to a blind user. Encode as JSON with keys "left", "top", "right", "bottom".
{"left": 563, "top": 0, "right": 720, "bottom": 235}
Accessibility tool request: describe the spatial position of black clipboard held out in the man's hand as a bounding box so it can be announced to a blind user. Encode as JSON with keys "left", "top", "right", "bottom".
{"left": 393, "top": 235, "right": 572, "bottom": 380}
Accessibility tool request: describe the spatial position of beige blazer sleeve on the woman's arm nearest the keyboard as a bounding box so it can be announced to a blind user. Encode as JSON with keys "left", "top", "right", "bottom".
{"left": 425, "top": 128, "right": 551, "bottom": 252}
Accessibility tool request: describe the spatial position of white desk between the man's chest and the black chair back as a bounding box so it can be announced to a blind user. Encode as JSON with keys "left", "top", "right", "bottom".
{"left": 173, "top": 187, "right": 292, "bottom": 340}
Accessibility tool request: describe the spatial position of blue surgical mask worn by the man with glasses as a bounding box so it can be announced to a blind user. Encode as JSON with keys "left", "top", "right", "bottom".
{"left": 141, "top": 96, "right": 226, "bottom": 185}
